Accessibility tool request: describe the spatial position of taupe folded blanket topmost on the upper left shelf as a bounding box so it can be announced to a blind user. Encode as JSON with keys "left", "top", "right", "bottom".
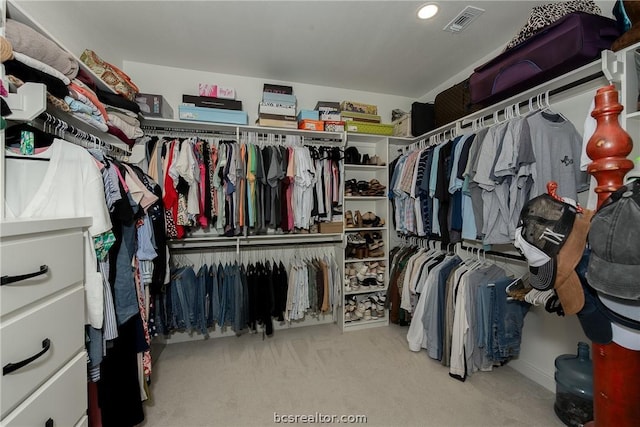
{"left": 4, "top": 19, "right": 79, "bottom": 79}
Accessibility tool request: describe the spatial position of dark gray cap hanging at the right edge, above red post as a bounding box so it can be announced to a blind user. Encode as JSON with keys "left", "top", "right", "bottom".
{"left": 587, "top": 180, "right": 640, "bottom": 300}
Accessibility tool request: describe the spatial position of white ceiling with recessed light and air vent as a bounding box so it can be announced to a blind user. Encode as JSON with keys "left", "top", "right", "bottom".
{"left": 11, "top": 0, "right": 614, "bottom": 98}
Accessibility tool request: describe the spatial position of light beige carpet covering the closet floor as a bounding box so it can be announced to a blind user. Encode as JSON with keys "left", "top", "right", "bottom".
{"left": 143, "top": 325, "right": 563, "bottom": 427}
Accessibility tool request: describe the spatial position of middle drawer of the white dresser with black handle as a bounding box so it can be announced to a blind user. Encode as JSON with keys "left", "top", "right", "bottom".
{"left": 0, "top": 285, "right": 84, "bottom": 417}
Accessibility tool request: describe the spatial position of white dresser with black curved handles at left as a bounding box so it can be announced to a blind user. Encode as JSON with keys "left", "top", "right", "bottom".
{"left": 0, "top": 218, "right": 91, "bottom": 427}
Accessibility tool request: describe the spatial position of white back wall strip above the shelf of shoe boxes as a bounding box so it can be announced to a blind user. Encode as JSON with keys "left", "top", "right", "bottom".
{"left": 124, "top": 61, "right": 415, "bottom": 124}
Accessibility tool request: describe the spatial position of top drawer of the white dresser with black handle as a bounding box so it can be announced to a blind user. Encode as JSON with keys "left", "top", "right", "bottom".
{"left": 0, "top": 230, "right": 84, "bottom": 319}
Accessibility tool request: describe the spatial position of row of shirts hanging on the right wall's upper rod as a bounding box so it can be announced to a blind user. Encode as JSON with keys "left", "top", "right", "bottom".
{"left": 389, "top": 97, "right": 587, "bottom": 244}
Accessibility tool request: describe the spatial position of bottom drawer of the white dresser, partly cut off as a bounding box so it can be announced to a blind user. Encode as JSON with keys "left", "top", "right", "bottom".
{"left": 0, "top": 351, "right": 88, "bottom": 427}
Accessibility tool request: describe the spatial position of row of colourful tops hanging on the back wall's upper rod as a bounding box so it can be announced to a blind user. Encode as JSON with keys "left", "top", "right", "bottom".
{"left": 147, "top": 133, "right": 343, "bottom": 238}
